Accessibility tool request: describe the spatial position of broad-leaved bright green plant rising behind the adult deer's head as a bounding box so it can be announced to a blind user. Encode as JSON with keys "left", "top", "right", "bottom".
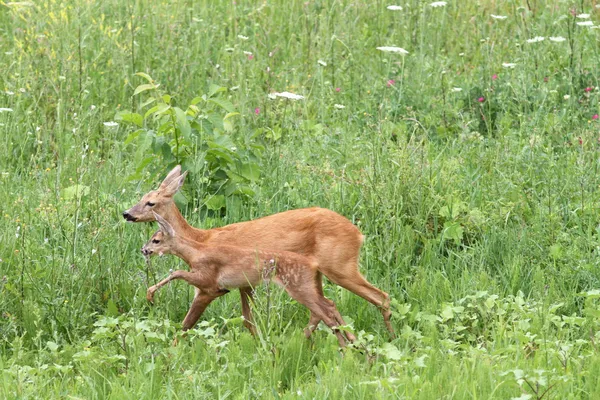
{"left": 115, "top": 72, "right": 264, "bottom": 210}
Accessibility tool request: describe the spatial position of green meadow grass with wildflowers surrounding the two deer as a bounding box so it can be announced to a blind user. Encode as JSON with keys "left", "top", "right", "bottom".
{"left": 0, "top": 0, "right": 600, "bottom": 399}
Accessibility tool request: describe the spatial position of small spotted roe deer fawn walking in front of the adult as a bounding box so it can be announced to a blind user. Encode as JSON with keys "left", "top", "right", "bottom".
{"left": 142, "top": 213, "right": 353, "bottom": 347}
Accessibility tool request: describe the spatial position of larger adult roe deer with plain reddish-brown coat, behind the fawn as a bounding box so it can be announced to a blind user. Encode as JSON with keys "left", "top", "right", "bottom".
{"left": 123, "top": 165, "right": 394, "bottom": 337}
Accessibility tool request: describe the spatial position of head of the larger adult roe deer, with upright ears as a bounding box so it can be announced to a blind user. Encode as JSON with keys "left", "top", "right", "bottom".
{"left": 123, "top": 165, "right": 187, "bottom": 222}
